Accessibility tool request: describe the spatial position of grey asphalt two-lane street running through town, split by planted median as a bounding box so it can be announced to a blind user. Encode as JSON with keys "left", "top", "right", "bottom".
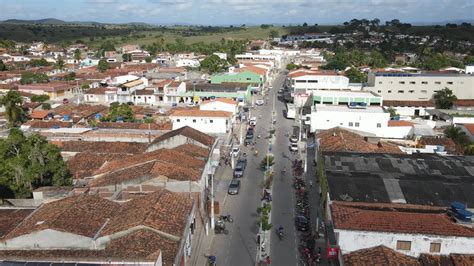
{"left": 212, "top": 69, "right": 297, "bottom": 266}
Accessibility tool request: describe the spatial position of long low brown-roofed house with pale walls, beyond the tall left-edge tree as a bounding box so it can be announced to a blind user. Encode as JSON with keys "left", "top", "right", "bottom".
{"left": 18, "top": 82, "right": 76, "bottom": 100}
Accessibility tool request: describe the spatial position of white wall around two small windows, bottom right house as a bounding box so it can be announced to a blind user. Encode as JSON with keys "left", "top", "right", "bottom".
{"left": 334, "top": 229, "right": 474, "bottom": 257}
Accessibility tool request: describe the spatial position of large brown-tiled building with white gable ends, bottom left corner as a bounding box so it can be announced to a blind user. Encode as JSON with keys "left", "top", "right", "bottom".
{"left": 0, "top": 189, "right": 195, "bottom": 265}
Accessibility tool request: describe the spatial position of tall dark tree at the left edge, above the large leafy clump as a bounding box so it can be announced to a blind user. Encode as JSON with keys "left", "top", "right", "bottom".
{"left": 0, "top": 90, "right": 26, "bottom": 128}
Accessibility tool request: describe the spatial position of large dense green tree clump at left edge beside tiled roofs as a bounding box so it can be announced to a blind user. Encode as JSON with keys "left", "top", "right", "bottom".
{"left": 0, "top": 128, "right": 72, "bottom": 199}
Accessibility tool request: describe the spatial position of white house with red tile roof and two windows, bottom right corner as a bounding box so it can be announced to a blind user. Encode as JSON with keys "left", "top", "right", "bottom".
{"left": 330, "top": 201, "right": 474, "bottom": 257}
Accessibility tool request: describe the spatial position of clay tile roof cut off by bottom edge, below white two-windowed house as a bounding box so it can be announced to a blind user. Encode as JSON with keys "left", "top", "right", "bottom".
{"left": 343, "top": 246, "right": 421, "bottom": 266}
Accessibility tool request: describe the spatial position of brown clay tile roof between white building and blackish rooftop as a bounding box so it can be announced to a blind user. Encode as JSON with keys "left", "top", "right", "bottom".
{"left": 317, "top": 127, "right": 402, "bottom": 153}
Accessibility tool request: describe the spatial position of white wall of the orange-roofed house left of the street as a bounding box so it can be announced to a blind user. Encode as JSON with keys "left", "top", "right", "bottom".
{"left": 170, "top": 116, "right": 232, "bottom": 134}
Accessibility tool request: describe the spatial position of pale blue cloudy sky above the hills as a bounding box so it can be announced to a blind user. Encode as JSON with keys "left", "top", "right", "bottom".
{"left": 0, "top": 0, "right": 474, "bottom": 25}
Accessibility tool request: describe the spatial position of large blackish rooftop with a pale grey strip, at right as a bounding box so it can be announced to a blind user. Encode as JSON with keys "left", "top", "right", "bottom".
{"left": 323, "top": 152, "right": 474, "bottom": 207}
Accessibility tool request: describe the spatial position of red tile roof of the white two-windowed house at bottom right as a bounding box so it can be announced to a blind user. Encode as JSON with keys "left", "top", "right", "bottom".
{"left": 331, "top": 201, "right": 474, "bottom": 237}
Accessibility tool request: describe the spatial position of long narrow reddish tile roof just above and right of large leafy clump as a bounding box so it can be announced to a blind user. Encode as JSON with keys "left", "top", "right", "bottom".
{"left": 51, "top": 141, "right": 148, "bottom": 154}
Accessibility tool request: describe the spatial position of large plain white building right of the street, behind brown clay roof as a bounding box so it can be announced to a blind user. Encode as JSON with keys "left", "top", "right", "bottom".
{"left": 311, "top": 104, "right": 390, "bottom": 137}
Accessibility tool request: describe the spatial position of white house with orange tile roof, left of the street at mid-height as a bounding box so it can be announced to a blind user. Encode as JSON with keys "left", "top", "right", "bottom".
{"left": 169, "top": 109, "right": 232, "bottom": 134}
